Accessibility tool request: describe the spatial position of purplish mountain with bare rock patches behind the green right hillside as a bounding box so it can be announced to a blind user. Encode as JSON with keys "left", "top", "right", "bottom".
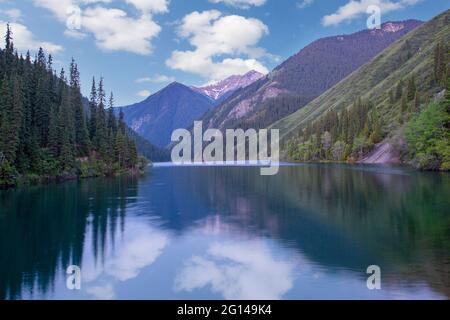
{"left": 200, "top": 20, "right": 422, "bottom": 129}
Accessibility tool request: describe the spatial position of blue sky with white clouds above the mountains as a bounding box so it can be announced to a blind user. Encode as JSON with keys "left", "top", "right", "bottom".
{"left": 0, "top": 0, "right": 450, "bottom": 105}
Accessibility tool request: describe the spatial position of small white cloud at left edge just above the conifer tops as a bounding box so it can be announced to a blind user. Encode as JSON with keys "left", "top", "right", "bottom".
{"left": 0, "top": 21, "right": 63, "bottom": 54}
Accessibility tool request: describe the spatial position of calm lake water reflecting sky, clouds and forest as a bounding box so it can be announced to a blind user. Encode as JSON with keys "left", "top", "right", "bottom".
{"left": 0, "top": 165, "right": 450, "bottom": 299}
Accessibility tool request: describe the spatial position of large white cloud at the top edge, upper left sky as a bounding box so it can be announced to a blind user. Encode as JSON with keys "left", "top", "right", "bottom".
{"left": 33, "top": 0, "right": 169, "bottom": 55}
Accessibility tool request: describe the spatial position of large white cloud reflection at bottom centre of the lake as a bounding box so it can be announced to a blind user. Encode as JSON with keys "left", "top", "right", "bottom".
{"left": 175, "top": 241, "right": 294, "bottom": 300}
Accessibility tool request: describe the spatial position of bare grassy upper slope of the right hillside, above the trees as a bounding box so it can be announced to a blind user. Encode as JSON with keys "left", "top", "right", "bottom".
{"left": 270, "top": 10, "right": 450, "bottom": 162}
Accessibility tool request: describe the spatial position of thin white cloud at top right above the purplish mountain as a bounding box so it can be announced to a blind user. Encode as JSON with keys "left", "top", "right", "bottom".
{"left": 322, "top": 0, "right": 421, "bottom": 26}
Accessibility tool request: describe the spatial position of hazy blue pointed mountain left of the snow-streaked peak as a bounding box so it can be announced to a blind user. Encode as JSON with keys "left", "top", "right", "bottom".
{"left": 122, "top": 82, "right": 214, "bottom": 148}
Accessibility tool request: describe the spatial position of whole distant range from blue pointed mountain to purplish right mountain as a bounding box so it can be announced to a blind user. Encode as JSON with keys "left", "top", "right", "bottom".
{"left": 122, "top": 20, "right": 422, "bottom": 147}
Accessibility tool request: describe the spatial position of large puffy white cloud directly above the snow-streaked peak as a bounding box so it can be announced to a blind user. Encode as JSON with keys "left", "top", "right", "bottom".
{"left": 166, "top": 10, "right": 269, "bottom": 81}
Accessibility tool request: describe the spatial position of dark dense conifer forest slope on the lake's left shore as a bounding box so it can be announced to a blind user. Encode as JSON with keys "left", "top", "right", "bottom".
{"left": 0, "top": 26, "right": 146, "bottom": 186}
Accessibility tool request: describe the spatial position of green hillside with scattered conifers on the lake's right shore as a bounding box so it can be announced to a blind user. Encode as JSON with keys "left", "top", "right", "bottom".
{"left": 278, "top": 11, "right": 450, "bottom": 170}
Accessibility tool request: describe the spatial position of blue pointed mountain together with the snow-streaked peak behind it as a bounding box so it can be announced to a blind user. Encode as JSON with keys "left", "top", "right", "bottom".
{"left": 122, "top": 71, "right": 264, "bottom": 148}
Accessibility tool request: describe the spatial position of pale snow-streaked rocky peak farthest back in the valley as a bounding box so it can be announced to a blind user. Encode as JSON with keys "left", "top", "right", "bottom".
{"left": 192, "top": 70, "right": 264, "bottom": 102}
